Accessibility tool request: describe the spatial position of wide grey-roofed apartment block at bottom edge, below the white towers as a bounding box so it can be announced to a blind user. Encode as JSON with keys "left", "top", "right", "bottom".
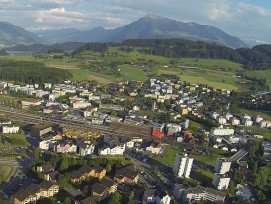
{"left": 182, "top": 186, "right": 226, "bottom": 204}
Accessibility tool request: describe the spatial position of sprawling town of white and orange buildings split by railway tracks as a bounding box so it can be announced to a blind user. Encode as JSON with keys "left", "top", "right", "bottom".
{"left": 0, "top": 75, "right": 271, "bottom": 204}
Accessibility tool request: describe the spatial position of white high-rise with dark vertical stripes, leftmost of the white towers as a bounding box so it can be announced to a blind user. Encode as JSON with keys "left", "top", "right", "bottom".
{"left": 173, "top": 154, "right": 194, "bottom": 178}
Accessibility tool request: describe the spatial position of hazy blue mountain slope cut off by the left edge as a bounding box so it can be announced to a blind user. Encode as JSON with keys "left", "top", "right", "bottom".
{"left": 0, "top": 22, "right": 45, "bottom": 47}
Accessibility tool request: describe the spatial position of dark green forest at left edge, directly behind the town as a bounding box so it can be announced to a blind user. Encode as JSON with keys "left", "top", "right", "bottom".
{"left": 0, "top": 60, "right": 72, "bottom": 84}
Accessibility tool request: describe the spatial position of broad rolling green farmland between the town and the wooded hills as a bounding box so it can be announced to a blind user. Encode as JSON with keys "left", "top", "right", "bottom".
{"left": 1, "top": 47, "right": 253, "bottom": 90}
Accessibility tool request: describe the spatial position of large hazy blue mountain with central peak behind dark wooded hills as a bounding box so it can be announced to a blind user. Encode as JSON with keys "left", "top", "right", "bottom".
{"left": 36, "top": 14, "right": 246, "bottom": 48}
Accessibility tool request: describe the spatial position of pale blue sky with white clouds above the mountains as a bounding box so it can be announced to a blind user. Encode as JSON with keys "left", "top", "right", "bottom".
{"left": 0, "top": 0, "right": 271, "bottom": 42}
